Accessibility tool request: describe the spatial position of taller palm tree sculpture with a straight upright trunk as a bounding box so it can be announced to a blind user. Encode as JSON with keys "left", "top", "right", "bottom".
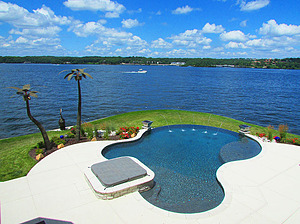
{"left": 60, "top": 69, "right": 93, "bottom": 141}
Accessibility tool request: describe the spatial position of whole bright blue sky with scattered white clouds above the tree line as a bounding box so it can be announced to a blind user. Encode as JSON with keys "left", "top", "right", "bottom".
{"left": 0, "top": 0, "right": 300, "bottom": 58}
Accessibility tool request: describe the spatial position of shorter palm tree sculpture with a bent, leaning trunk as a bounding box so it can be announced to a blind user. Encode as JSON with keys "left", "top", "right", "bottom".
{"left": 8, "top": 84, "right": 52, "bottom": 150}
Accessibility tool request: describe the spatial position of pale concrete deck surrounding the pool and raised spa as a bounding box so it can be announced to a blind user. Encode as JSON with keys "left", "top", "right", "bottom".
{"left": 0, "top": 130, "right": 300, "bottom": 224}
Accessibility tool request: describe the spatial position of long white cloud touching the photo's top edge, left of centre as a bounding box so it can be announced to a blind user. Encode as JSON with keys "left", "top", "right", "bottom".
{"left": 64, "top": 0, "right": 125, "bottom": 14}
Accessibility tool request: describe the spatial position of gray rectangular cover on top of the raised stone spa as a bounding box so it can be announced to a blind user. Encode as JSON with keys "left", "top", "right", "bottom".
{"left": 91, "top": 157, "right": 147, "bottom": 187}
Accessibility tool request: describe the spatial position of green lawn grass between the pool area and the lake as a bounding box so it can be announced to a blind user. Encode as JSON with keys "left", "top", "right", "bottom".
{"left": 0, "top": 110, "right": 300, "bottom": 181}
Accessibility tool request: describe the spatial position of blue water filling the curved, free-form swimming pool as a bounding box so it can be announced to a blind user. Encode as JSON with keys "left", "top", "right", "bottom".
{"left": 103, "top": 125, "right": 261, "bottom": 213}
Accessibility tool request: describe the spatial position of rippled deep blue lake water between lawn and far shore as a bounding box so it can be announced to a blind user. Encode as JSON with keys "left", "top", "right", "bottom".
{"left": 0, "top": 64, "right": 300, "bottom": 138}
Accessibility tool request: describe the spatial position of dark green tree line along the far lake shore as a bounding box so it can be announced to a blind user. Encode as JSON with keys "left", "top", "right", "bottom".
{"left": 0, "top": 56, "right": 300, "bottom": 69}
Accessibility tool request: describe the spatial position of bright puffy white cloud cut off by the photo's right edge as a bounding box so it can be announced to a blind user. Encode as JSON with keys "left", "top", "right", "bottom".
{"left": 259, "top": 19, "right": 300, "bottom": 36}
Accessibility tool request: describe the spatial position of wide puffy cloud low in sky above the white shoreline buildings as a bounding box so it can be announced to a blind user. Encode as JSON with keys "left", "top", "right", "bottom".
{"left": 169, "top": 29, "right": 212, "bottom": 48}
